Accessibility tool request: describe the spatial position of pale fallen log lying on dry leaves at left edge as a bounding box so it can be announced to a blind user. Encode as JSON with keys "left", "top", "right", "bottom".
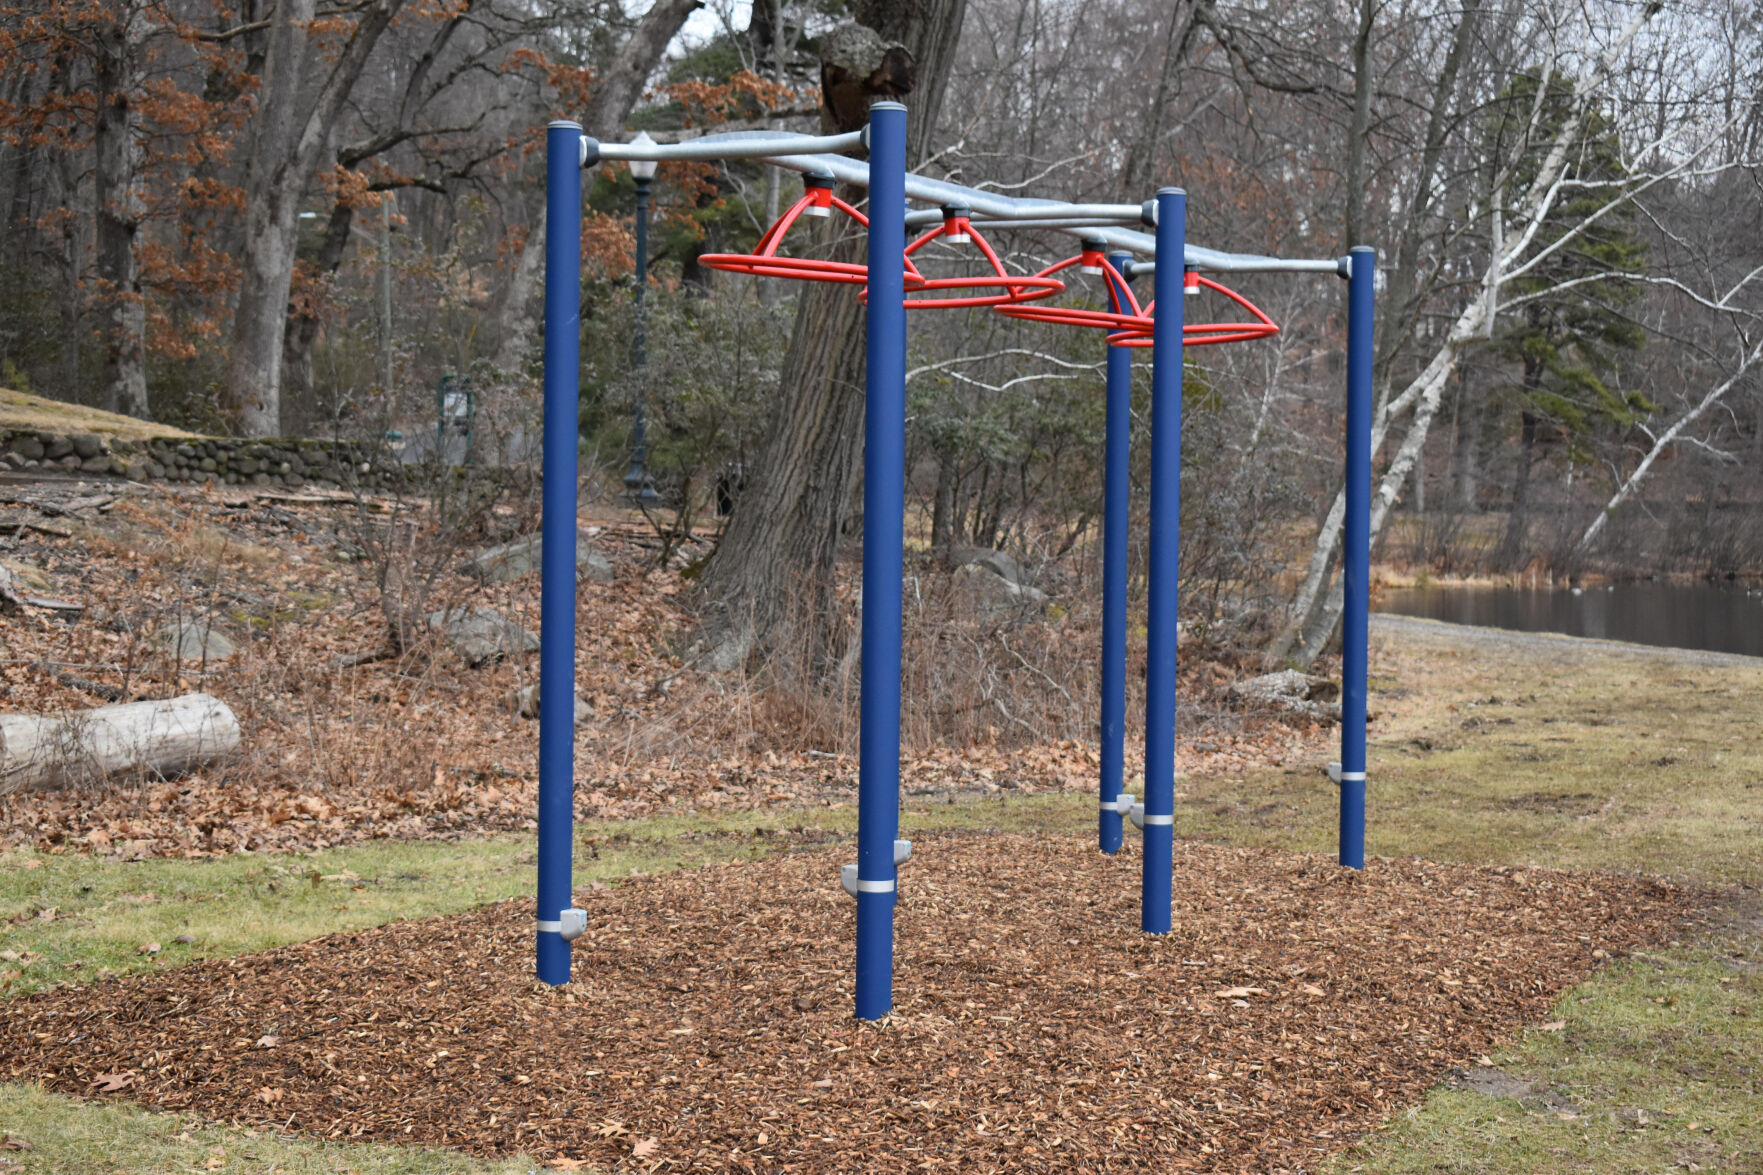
{"left": 0, "top": 693, "right": 238, "bottom": 796}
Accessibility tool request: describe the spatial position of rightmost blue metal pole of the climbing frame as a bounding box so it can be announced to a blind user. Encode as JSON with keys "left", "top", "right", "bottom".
{"left": 1340, "top": 245, "right": 1377, "bottom": 870}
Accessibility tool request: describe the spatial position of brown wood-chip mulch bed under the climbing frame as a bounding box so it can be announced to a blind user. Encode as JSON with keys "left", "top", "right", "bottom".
{"left": 0, "top": 834, "right": 1692, "bottom": 1171}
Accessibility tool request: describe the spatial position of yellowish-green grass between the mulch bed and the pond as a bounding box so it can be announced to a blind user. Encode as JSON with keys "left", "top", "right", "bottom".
{"left": 1176, "top": 632, "right": 1763, "bottom": 886}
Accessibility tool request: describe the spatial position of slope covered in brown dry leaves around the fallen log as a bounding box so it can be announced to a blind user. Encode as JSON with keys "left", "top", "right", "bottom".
{"left": 0, "top": 482, "right": 1331, "bottom": 857}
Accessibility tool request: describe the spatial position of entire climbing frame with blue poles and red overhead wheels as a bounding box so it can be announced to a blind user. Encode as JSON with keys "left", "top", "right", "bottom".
{"left": 536, "top": 112, "right": 1377, "bottom": 1020}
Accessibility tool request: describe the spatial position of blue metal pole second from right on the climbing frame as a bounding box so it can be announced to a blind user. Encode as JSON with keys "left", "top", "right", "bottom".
{"left": 1141, "top": 187, "right": 1188, "bottom": 935}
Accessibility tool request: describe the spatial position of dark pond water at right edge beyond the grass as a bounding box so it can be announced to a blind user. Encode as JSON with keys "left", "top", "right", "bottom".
{"left": 1375, "top": 584, "right": 1763, "bottom": 656}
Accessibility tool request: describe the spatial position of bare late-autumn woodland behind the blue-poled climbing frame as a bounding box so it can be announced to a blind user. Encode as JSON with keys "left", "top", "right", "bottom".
{"left": 0, "top": 0, "right": 1763, "bottom": 669}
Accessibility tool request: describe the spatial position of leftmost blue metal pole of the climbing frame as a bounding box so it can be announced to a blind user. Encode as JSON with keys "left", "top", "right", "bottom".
{"left": 538, "top": 122, "right": 582, "bottom": 984}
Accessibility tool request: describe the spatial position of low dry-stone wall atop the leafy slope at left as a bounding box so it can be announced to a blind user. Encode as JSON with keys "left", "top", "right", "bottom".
{"left": 0, "top": 429, "right": 405, "bottom": 489}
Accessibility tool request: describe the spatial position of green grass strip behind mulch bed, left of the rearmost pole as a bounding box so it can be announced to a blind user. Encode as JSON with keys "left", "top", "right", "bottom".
{"left": 0, "top": 797, "right": 1093, "bottom": 995}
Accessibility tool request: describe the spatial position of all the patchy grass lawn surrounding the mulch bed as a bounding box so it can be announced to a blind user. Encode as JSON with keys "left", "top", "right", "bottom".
{"left": 0, "top": 617, "right": 1763, "bottom": 1175}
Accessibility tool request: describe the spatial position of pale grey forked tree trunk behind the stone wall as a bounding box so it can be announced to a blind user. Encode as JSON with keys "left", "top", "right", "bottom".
{"left": 227, "top": 0, "right": 404, "bottom": 436}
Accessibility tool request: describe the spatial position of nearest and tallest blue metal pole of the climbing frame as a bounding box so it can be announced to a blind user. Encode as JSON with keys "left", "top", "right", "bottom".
{"left": 857, "top": 102, "right": 906, "bottom": 1020}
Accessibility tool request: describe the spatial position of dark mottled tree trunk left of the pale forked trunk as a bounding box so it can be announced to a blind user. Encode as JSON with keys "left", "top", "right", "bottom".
{"left": 92, "top": 7, "right": 148, "bottom": 418}
